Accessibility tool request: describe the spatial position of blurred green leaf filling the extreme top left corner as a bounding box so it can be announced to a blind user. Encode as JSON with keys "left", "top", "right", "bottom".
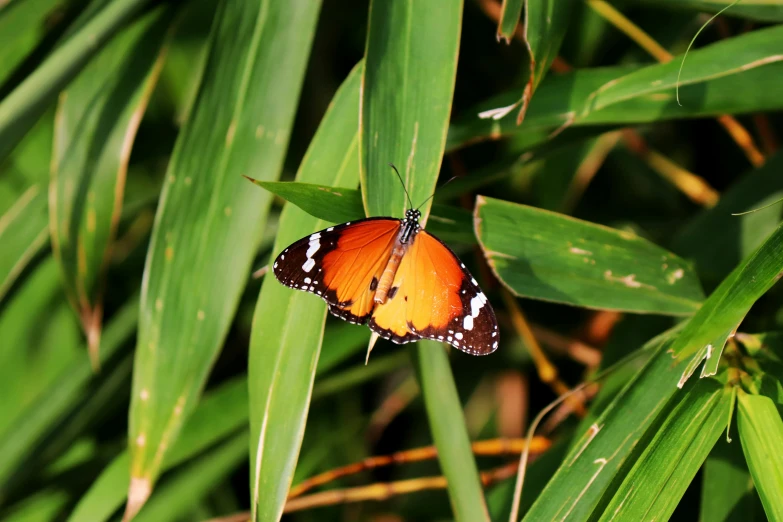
{"left": 0, "top": 0, "right": 69, "bottom": 86}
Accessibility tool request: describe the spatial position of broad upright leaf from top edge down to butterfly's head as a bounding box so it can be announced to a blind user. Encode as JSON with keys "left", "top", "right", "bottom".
{"left": 359, "top": 0, "right": 462, "bottom": 223}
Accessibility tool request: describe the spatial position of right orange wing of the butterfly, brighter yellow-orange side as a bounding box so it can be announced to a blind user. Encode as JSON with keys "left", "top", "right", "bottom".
{"left": 368, "top": 231, "right": 499, "bottom": 355}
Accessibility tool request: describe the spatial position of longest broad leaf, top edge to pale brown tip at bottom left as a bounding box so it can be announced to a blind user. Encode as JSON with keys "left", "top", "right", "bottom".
{"left": 126, "top": 0, "right": 319, "bottom": 518}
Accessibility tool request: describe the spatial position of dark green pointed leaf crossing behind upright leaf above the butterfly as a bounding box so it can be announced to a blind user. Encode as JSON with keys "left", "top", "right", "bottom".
{"left": 248, "top": 181, "right": 476, "bottom": 243}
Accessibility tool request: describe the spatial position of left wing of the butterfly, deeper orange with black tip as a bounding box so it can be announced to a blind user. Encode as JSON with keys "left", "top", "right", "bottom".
{"left": 273, "top": 218, "right": 400, "bottom": 324}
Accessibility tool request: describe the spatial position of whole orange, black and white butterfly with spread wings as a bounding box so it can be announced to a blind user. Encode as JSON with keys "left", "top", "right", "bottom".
{"left": 273, "top": 165, "right": 499, "bottom": 355}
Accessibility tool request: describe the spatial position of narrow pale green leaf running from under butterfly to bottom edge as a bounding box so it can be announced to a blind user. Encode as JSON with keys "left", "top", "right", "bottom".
{"left": 411, "top": 341, "right": 489, "bottom": 521}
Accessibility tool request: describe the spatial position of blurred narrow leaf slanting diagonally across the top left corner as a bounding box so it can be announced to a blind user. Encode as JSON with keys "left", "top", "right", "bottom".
{"left": 0, "top": 0, "right": 154, "bottom": 162}
